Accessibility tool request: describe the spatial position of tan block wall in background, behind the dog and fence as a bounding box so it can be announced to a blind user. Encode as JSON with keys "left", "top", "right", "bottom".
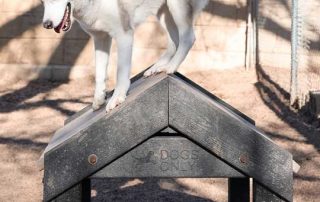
{"left": 0, "top": 0, "right": 320, "bottom": 92}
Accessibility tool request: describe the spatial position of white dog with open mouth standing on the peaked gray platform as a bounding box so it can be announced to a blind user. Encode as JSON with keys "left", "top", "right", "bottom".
{"left": 43, "top": 0, "right": 208, "bottom": 112}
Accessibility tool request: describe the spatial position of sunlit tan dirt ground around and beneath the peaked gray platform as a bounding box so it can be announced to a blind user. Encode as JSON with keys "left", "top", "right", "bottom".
{"left": 0, "top": 69, "right": 320, "bottom": 202}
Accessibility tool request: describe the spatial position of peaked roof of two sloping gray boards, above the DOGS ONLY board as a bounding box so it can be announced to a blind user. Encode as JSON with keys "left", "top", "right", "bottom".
{"left": 44, "top": 72, "right": 293, "bottom": 201}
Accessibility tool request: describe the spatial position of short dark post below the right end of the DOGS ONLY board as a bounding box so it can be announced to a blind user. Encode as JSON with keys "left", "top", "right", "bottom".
{"left": 228, "top": 178, "right": 250, "bottom": 202}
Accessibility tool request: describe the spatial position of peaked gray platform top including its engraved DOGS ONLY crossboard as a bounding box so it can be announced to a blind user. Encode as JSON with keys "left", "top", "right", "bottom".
{"left": 44, "top": 74, "right": 293, "bottom": 201}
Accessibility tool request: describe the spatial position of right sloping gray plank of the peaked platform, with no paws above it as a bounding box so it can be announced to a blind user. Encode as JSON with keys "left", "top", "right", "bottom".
{"left": 169, "top": 76, "right": 293, "bottom": 201}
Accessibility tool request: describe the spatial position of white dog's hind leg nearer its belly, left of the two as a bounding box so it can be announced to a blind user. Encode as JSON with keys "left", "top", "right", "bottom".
{"left": 144, "top": 5, "right": 179, "bottom": 76}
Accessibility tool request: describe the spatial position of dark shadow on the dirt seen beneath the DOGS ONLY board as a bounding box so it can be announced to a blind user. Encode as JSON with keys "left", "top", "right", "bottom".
{"left": 92, "top": 179, "right": 216, "bottom": 202}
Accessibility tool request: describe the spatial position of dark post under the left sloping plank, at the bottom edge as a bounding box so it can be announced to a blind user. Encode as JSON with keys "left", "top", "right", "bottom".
{"left": 52, "top": 179, "right": 91, "bottom": 202}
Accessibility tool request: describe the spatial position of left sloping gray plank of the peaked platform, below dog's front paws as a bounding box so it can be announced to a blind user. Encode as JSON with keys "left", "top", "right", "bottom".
{"left": 44, "top": 75, "right": 168, "bottom": 201}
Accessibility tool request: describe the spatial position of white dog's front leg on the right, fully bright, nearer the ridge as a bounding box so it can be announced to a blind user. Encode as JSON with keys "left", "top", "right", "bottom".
{"left": 106, "top": 31, "right": 133, "bottom": 112}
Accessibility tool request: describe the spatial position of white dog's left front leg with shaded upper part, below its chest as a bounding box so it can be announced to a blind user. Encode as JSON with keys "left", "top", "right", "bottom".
{"left": 92, "top": 33, "right": 112, "bottom": 110}
